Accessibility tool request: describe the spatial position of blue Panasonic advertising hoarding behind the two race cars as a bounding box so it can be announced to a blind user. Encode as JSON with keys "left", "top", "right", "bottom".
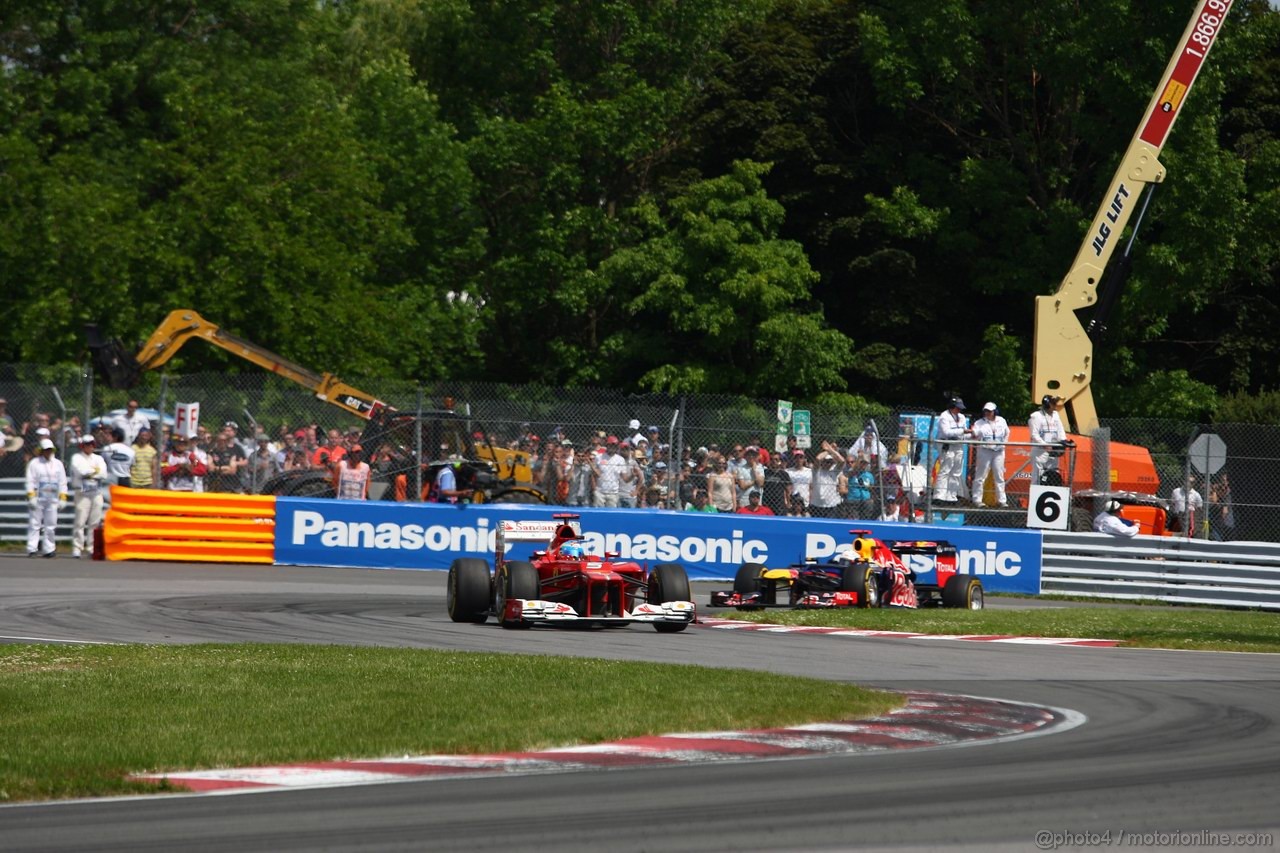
{"left": 275, "top": 497, "right": 1041, "bottom": 594}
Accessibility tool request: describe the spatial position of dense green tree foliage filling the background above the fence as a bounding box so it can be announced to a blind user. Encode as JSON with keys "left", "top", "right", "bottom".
{"left": 0, "top": 0, "right": 1280, "bottom": 416}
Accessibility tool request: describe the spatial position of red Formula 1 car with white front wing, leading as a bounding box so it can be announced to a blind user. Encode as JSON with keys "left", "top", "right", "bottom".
{"left": 447, "top": 512, "right": 695, "bottom": 633}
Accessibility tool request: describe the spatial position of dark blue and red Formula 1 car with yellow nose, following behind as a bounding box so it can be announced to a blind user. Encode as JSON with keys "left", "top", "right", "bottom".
{"left": 710, "top": 530, "right": 983, "bottom": 610}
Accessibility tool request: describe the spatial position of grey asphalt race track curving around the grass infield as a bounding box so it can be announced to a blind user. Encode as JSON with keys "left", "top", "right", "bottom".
{"left": 0, "top": 556, "right": 1280, "bottom": 853}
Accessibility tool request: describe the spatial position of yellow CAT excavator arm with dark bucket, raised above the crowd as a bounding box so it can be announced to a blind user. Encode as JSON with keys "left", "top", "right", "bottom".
{"left": 88, "top": 309, "right": 387, "bottom": 420}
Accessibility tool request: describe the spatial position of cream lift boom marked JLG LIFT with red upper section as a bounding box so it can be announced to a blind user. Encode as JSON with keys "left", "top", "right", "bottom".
{"left": 1032, "top": 0, "right": 1233, "bottom": 433}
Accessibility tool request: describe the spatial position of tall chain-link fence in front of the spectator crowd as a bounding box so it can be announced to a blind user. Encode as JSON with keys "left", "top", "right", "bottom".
{"left": 0, "top": 365, "right": 1280, "bottom": 542}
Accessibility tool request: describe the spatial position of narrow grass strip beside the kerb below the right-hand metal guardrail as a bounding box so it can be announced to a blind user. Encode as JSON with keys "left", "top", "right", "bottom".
{"left": 716, "top": 605, "right": 1280, "bottom": 652}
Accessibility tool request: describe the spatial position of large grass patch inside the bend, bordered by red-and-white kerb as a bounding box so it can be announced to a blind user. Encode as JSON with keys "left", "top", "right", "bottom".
{"left": 0, "top": 644, "right": 901, "bottom": 800}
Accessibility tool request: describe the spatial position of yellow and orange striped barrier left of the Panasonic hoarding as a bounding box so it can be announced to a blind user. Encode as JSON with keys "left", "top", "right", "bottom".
{"left": 102, "top": 485, "right": 275, "bottom": 562}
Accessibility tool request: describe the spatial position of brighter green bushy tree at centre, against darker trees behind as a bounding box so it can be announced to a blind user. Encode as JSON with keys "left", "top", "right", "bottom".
{"left": 599, "top": 161, "right": 852, "bottom": 397}
